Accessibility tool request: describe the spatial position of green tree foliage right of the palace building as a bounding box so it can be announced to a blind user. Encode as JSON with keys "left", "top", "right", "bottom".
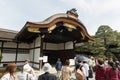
{"left": 75, "top": 25, "right": 120, "bottom": 57}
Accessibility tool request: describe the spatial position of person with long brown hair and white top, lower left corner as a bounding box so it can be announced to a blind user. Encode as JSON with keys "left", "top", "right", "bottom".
{"left": 0, "top": 63, "right": 17, "bottom": 80}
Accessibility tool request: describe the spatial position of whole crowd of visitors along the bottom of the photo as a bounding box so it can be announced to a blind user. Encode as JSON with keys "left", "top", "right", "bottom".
{"left": 0, "top": 57, "right": 120, "bottom": 80}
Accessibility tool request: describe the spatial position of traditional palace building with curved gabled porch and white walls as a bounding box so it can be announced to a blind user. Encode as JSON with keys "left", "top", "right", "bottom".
{"left": 0, "top": 9, "right": 93, "bottom": 69}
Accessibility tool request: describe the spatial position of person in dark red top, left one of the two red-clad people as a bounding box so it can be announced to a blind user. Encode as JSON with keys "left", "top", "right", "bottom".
{"left": 94, "top": 58, "right": 106, "bottom": 80}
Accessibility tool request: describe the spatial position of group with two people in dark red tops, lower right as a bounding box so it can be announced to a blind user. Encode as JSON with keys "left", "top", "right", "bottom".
{"left": 94, "top": 58, "right": 120, "bottom": 80}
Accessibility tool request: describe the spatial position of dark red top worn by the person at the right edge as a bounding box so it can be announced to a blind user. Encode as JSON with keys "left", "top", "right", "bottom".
{"left": 106, "top": 68, "right": 120, "bottom": 80}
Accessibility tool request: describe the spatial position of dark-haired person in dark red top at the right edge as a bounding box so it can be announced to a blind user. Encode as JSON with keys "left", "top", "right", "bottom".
{"left": 106, "top": 61, "right": 120, "bottom": 80}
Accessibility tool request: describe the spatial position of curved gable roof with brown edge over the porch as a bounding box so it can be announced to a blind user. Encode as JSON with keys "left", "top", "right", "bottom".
{"left": 16, "top": 9, "right": 93, "bottom": 41}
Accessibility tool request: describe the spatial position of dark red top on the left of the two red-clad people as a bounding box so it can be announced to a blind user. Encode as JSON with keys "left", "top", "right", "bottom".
{"left": 94, "top": 66, "right": 106, "bottom": 80}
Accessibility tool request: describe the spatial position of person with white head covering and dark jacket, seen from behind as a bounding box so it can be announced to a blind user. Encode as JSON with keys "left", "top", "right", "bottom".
{"left": 38, "top": 63, "right": 57, "bottom": 80}
